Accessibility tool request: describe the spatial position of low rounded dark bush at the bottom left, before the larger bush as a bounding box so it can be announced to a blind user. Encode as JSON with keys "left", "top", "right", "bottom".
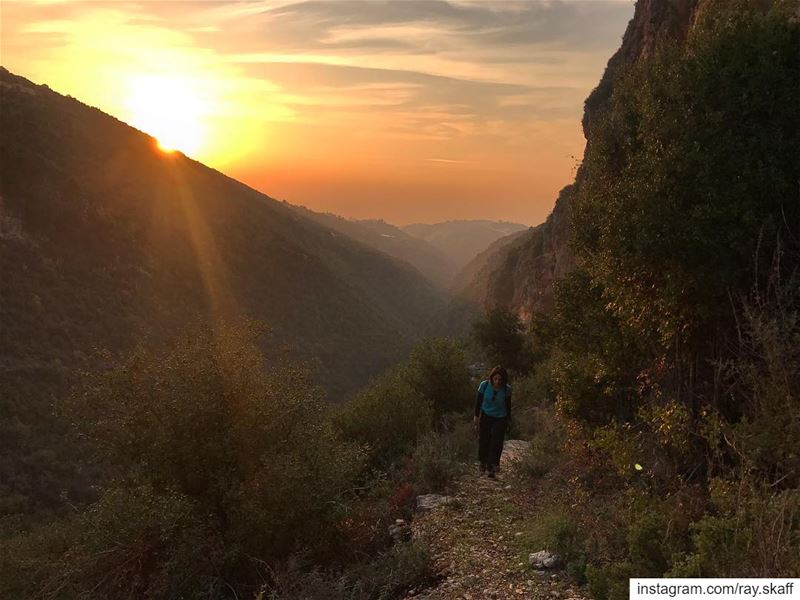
{"left": 38, "top": 486, "right": 217, "bottom": 600}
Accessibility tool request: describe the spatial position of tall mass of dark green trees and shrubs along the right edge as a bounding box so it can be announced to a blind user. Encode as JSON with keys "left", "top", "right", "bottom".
{"left": 545, "top": 1, "right": 800, "bottom": 584}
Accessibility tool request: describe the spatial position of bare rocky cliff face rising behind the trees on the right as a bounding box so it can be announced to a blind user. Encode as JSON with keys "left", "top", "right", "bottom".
{"left": 457, "top": 0, "right": 716, "bottom": 322}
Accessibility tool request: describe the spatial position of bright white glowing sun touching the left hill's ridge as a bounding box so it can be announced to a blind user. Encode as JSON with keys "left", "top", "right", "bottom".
{"left": 126, "top": 75, "right": 208, "bottom": 155}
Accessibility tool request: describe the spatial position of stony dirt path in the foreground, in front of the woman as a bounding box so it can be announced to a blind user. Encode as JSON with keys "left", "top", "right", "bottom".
{"left": 406, "top": 442, "right": 583, "bottom": 600}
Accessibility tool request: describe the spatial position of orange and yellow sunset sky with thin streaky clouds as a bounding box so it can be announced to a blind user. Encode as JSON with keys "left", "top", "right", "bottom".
{"left": 0, "top": 0, "right": 634, "bottom": 225}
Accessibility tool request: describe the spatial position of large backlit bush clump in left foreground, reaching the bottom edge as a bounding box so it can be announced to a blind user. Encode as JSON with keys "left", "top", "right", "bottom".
{"left": 46, "top": 324, "right": 363, "bottom": 598}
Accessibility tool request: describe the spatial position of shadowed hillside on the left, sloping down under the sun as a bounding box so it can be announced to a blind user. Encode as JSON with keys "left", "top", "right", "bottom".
{"left": 0, "top": 69, "right": 443, "bottom": 511}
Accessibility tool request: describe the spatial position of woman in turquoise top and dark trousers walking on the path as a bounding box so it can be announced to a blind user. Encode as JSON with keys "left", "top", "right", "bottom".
{"left": 473, "top": 365, "right": 511, "bottom": 479}
